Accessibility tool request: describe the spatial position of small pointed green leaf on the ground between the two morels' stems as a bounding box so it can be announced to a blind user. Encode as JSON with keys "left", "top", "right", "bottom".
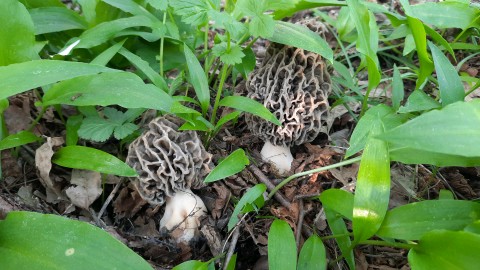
{"left": 204, "top": 148, "right": 250, "bottom": 183}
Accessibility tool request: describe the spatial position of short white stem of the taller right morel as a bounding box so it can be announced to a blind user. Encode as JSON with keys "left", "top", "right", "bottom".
{"left": 260, "top": 141, "right": 293, "bottom": 176}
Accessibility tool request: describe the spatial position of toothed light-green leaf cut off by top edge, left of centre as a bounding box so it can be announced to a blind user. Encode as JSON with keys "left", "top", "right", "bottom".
{"left": 169, "top": 0, "right": 212, "bottom": 26}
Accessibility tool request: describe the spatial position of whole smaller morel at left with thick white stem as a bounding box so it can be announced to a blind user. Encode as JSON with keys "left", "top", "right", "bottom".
{"left": 126, "top": 116, "right": 211, "bottom": 243}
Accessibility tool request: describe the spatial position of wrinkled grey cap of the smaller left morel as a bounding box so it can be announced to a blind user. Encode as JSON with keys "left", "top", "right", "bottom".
{"left": 126, "top": 116, "right": 212, "bottom": 205}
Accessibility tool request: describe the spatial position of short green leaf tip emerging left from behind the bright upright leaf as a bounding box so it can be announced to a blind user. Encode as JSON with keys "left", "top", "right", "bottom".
{"left": 319, "top": 189, "right": 354, "bottom": 220}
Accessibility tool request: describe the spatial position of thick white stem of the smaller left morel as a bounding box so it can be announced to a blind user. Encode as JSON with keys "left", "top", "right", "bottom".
{"left": 160, "top": 189, "right": 207, "bottom": 243}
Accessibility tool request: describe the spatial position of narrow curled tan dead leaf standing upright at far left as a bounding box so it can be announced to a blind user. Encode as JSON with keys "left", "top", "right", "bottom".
{"left": 35, "top": 137, "right": 64, "bottom": 198}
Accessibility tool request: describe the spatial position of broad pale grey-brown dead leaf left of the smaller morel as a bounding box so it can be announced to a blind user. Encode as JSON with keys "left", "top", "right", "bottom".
{"left": 65, "top": 169, "right": 102, "bottom": 209}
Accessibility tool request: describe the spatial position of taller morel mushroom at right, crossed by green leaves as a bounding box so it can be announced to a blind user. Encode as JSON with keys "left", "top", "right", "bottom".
{"left": 246, "top": 20, "right": 331, "bottom": 175}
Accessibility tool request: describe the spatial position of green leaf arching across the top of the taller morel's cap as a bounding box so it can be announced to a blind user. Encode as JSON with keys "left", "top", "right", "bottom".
{"left": 268, "top": 21, "right": 333, "bottom": 63}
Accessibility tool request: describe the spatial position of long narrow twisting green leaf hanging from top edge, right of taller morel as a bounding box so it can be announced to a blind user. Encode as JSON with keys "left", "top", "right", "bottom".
{"left": 347, "top": 0, "right": 381, "bottom": 99}
